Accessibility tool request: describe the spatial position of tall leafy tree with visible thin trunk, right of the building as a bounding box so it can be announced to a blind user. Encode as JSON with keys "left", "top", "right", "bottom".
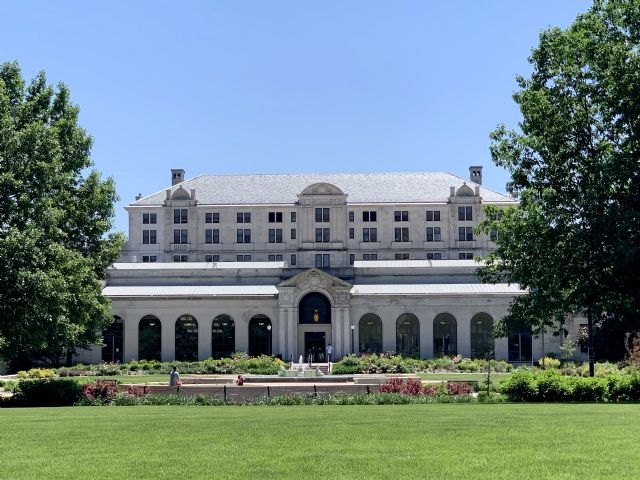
{"left": 478, "top": 0, "right": 640, "bottom": 372}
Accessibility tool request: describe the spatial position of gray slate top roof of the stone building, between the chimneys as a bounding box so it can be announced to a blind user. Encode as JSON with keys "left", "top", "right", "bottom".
{"left": 131, "top": 172, "right": 514, "bottom": 206}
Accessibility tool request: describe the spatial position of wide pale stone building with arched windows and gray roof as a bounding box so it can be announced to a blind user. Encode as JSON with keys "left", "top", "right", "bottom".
{"left": 85, "top": 166, "right": 584, "bottom": 362}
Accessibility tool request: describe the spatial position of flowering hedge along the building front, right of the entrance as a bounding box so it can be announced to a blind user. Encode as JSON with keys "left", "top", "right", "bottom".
{"left": 331, "top": 355, "right": 513, "bottom": 375}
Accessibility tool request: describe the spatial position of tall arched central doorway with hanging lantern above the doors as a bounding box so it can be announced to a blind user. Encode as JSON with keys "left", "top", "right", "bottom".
{"left": 298, "top": 292, "right": 331, "bottom": 362}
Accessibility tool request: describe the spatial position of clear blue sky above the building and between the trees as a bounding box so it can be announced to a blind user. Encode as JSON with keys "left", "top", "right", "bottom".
{"left": 0, "top": 0, "right": 591, "bottom": 231}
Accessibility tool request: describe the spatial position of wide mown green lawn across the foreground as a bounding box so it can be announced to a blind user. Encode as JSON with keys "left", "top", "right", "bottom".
{"left": 0, "top": 404, "right": 640, "bottom": 480}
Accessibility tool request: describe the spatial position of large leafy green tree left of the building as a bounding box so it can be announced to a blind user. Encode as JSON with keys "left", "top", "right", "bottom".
{"left": 0, "top": 62, "right": 123, "bottom": 364}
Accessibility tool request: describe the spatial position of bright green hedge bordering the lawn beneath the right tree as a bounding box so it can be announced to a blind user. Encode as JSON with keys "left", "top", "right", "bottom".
{"left": 499, "top": 370, "right": 640, "bottom": 402}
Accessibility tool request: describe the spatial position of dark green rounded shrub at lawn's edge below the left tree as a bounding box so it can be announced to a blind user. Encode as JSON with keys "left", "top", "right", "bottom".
{"left": 14, "top": 378, "right": 82, "bottom": 407}
